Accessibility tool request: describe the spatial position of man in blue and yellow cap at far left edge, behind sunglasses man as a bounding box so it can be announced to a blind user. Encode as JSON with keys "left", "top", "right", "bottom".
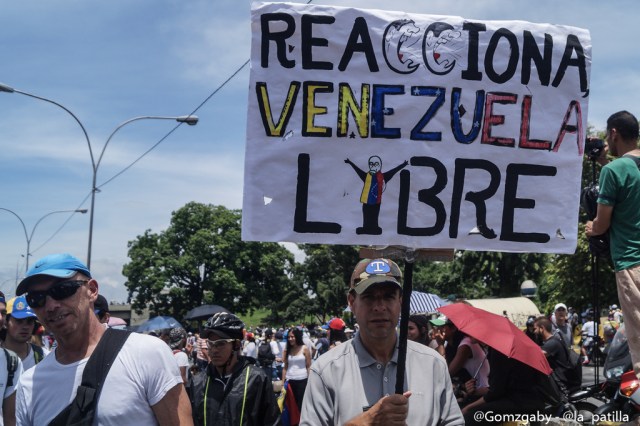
{"left": 2, "top": 296, "right": 49, "bottom": 371}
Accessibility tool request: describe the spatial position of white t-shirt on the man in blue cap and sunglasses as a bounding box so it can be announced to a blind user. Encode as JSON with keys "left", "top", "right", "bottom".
{"left": 16, "top": 333, "right": 182, "bottom": 426}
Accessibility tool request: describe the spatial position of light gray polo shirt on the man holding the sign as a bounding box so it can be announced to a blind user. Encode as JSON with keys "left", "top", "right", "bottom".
{"left": 300, "top": 334, "right": 464, "bottom": 426}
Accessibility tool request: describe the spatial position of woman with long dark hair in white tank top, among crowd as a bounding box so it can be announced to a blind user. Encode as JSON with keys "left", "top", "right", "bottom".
{"left": 282, "top": 328, "right": 311, "bottom": 418}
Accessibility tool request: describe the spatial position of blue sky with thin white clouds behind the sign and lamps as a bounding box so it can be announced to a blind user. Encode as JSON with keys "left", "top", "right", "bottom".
{"left": 0, "top": 0, "right": 640, "bottom": 301}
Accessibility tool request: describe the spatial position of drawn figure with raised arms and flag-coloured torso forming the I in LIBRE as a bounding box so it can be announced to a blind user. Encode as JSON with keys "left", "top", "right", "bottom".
{"left": 344, "top": 155, "right": 409, "bottom": 235}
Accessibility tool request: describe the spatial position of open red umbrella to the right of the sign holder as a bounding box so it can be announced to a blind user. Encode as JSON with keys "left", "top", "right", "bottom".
{"left": 438, "top": 303, "right": 551, "bottom": 374}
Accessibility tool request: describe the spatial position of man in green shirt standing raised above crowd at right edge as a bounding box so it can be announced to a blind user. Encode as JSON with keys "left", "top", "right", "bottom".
{"left": 585, "top": 111, "right": 640, "bottom": 377}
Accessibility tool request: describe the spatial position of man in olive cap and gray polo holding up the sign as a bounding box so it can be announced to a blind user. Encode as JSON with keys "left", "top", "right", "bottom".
{"left": 300, "top": 259, "right": 464, "bottom": 426}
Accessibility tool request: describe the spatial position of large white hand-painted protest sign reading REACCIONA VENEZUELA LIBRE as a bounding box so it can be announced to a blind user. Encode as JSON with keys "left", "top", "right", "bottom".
{"left": 242, "top": 3, "right": 591, "bottom": 253}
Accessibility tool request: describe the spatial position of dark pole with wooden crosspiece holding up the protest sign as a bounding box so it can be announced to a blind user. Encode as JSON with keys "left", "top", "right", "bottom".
{"left": 360, "top": 246, "right": 453, "bottom": 394}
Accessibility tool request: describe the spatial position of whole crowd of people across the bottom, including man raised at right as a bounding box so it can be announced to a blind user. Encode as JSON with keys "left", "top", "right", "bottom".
{"left": 5, "top": 107, "right": 640, "bottom": 426}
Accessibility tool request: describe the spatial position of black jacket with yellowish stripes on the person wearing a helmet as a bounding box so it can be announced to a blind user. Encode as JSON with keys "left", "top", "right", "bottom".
{"left": 189, "top": 357, "right": 280, "bottom": 426}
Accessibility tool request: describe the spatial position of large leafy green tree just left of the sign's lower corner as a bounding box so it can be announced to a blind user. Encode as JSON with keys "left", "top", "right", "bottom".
{"left": 122, "top": 202, "right": 294, "bottom": 318}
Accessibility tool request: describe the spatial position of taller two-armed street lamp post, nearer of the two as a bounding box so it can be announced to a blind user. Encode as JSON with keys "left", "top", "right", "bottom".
{"left": 0, "top": 83, "right": 198, "bottom": 268}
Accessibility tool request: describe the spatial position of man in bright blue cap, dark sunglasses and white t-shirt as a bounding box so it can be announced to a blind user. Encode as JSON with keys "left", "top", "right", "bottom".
{"left": 16, "top": 254, "right": 191, "bottom": 425}
